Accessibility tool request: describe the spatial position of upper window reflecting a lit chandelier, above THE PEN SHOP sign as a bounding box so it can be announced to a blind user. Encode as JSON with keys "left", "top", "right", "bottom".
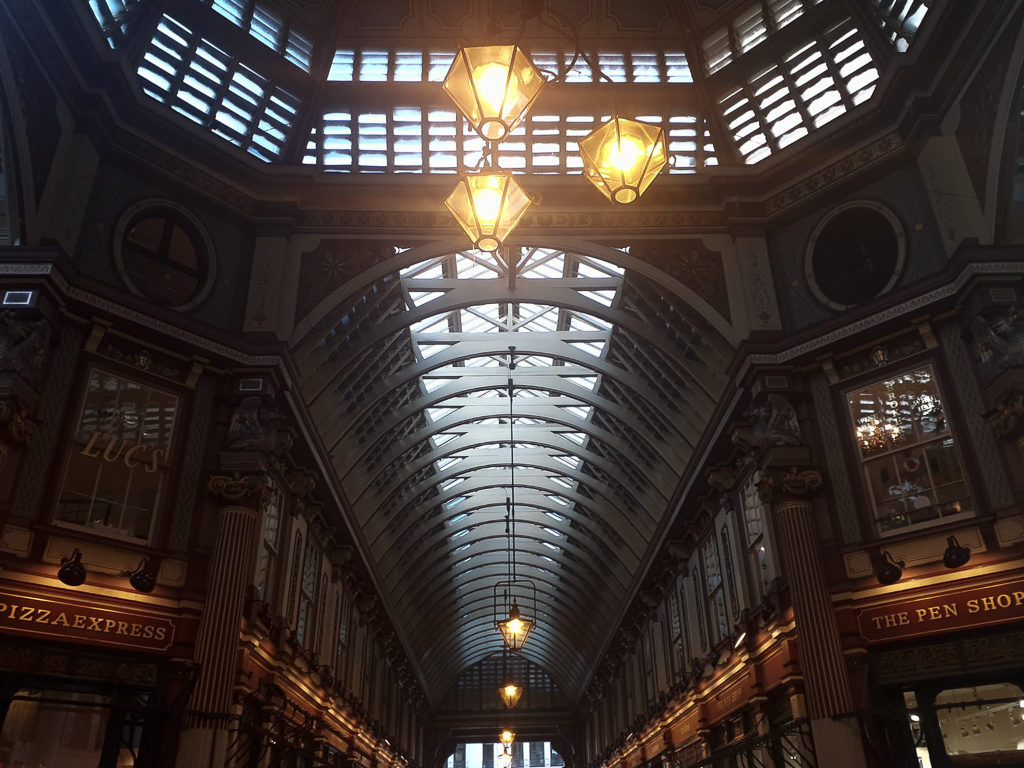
{"left": 848, "top": 366, "right": 972, "bottom": 536}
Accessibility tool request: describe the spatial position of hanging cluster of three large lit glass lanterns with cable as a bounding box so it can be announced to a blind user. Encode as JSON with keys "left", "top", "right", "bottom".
{"left": 443, "top": 6, "right": 669, "bottom": 251}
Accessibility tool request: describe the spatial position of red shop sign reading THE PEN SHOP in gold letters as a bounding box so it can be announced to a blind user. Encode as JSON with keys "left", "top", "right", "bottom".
{"left": 857, "top": 580, "right": 1024, "bottom": 642}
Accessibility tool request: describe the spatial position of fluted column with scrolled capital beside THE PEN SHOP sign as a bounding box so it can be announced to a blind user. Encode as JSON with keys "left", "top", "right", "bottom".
{"left": 758, "top": 467, "right": 866, "bottom": 768}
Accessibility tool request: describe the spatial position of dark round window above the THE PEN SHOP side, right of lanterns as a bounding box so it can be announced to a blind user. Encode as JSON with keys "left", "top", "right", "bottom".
{"left": 806, "top": 201, "right": 905, "bottom": 309}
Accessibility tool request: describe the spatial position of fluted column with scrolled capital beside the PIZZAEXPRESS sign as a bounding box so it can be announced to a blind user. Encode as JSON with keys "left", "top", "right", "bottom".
{"left": 176, "top": 472, "right": 268, "bottom": 768}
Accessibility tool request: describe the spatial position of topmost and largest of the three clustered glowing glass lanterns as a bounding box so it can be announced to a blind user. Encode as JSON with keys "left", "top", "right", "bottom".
{"left": 443, "top": 45, "right": 546, "bottom": 141}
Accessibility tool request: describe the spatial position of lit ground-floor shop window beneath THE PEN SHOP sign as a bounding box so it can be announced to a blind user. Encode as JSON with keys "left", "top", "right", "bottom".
{"left": 903, "top": 683, "right": 1024, "bottom": 768}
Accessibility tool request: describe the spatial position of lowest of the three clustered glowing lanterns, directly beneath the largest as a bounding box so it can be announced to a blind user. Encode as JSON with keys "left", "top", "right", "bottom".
{"left": 444, "top": 172, "right": 534, "bottom": 251}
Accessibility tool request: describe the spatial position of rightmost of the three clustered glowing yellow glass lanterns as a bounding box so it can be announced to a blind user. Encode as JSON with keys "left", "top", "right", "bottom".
{"left": 580, "top": 118, "right": 669, "bottom": 203}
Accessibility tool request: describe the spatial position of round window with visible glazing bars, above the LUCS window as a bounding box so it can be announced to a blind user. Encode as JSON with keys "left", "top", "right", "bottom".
{"left": 114, "top": 201, "right": 214, "bottom": 309}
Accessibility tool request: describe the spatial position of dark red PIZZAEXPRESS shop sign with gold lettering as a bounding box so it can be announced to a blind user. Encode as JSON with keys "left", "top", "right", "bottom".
{"left": 0, "top": 590, "right": 175, "bottom": 651}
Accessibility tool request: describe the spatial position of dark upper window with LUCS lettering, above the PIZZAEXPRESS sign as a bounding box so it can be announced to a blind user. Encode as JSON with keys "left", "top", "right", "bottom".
{"left": 56, "top": 369, "right": 180, "bottom": 541}
